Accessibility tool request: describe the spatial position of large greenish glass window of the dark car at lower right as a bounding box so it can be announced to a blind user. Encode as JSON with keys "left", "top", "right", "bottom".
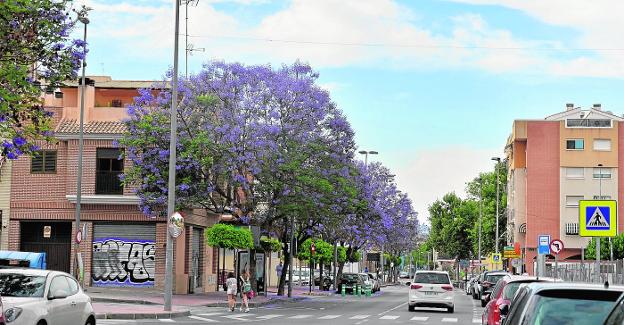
{"left": 523, "top": 290, "right": 620, "bottom": 325}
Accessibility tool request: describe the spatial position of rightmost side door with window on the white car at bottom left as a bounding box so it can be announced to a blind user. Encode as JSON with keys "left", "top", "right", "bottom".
{"left": 46, "top": 275, "right": 79, "bottom": 325}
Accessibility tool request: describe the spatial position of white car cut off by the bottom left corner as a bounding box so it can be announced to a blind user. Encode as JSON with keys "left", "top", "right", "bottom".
{"left": 0, "top": 269, "right": 95, "bottom": 325}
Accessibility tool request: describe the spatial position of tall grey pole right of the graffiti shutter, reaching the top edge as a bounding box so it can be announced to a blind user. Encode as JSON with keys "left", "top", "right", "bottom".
{"left": 164, "top": 0, "right": 180, "bottom": 311}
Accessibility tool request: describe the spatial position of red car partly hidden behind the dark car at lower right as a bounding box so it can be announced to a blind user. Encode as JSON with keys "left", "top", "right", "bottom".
{"left": 481, "top": 275, "right": 554, "bottom": 325}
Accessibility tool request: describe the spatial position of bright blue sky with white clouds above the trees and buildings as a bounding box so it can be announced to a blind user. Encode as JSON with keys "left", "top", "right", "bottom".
{"left": 76, "top": 0, "right": 624, "bottom": 223}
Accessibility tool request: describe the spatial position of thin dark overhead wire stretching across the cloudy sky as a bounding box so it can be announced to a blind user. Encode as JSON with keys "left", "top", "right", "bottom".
{"left": 182, "top": 35, "right": 624, "bottom": 52}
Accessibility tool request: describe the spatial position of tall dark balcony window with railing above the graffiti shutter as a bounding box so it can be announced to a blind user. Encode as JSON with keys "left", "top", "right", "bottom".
{"left": 95, "top": 148, "right": 123, "bottom": 194}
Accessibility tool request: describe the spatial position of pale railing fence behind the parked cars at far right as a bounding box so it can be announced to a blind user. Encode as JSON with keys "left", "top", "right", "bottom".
{"left": 545, "top": 260, "right": 624, "bottom": 285}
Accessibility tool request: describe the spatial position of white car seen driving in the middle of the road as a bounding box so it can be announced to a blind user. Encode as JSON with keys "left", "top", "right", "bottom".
{"left": 407, "top": 271, "right": 455, "bottom": 313}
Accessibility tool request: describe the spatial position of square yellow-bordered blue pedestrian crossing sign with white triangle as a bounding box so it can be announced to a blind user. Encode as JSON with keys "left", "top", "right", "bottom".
{"left": 579, "top": 200, "right": 617, "bottom": 237}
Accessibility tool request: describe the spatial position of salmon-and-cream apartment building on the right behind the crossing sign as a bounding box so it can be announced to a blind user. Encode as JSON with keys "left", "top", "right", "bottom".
{"left": 506, "top": 104, "right": 624, "bottom": 274}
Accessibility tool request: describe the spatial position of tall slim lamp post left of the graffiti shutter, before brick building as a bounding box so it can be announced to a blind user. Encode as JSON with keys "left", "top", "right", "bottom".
{"left": 74, "top": 7, "right": 89, "bottom": 281}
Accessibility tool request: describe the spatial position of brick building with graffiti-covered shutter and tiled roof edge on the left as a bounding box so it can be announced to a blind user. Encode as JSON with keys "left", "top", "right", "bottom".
{"left": 0, "top": 77, "right": 216, "bottom": 293}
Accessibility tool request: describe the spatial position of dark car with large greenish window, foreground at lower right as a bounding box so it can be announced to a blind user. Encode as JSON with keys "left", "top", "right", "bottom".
{"left": 500, "top": 282, "right": 624, "bottom": 325}
